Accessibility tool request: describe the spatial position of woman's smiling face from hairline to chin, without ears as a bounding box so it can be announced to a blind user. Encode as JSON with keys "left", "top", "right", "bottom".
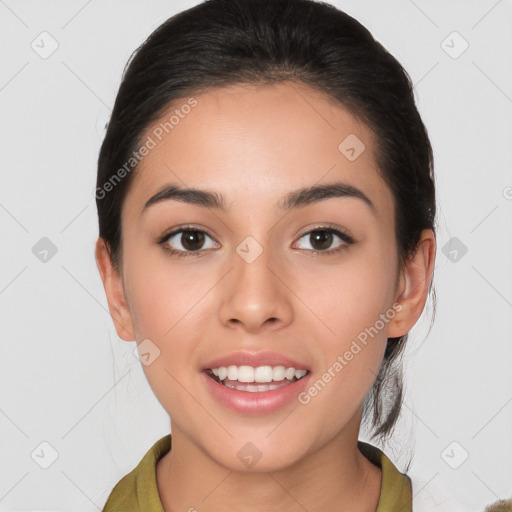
{"left": 102, "top": 82, "right": 410, "bottom": 471}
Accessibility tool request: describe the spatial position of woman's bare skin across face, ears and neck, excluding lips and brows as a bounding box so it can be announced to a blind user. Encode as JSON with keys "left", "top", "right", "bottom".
{"left": 96, "top": 82, "right": 435, "bottom": 512}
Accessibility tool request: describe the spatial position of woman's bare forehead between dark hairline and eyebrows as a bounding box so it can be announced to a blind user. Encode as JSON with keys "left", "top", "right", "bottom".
{"left": 123, "top": 82, "right": 393, "bottom": 220}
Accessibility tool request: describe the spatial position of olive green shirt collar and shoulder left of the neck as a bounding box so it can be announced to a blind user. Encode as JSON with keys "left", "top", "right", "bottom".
{"left": 102, "top": 434, "right": 171, "bottom": 512}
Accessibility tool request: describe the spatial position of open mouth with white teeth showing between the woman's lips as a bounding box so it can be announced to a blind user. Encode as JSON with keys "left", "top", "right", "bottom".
{"left": 204, "top": 365, "right": 309, "bottom": 393}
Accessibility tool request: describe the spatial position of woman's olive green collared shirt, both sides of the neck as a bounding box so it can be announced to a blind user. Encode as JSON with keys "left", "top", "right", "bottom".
{"left": 102, "top": 434, "right": 412, "bottom": 512}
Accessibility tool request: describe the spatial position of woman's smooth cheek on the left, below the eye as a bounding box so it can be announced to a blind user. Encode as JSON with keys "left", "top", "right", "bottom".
{"left": 121, "top": 244, "right": 211, "bottom": 390}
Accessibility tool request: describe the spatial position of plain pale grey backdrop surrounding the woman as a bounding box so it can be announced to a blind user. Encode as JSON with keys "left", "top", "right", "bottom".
{"left": 0, "top": 0, "right": 512, "bottom": 512}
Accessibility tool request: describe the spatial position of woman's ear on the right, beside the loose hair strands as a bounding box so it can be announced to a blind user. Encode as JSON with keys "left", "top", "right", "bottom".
{"left": 388, "top": 229, "right": 436, "bottom": 338}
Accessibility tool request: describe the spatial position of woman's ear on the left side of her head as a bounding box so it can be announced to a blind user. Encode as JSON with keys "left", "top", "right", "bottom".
{"left": 95, "top": 237, "right": 135, "bottom": 341}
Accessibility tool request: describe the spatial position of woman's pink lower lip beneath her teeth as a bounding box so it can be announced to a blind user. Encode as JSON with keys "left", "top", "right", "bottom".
{"left": 201, "top": 371, "right": 311, "bottom": 415}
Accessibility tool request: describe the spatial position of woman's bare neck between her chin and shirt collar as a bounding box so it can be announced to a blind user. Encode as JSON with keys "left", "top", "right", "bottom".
{"left": 157, "top": 412, "right": 381, "bottom": 512}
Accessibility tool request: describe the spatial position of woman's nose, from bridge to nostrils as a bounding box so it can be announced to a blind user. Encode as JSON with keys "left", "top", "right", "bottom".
{"left": 219, "top": 242, "right": 293, "bottom": 333}
